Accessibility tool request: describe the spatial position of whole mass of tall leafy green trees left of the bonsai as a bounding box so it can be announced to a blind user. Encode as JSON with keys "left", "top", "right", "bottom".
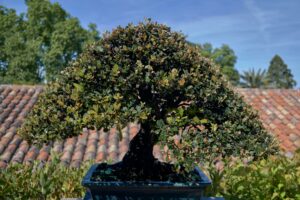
{"left": 0, "top": 0, "right": 99, "bottom": 83}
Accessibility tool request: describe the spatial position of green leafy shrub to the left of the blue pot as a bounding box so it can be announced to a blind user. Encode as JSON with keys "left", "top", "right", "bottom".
{"left": 0, "top": 153, "right": 90, "bottom": 200}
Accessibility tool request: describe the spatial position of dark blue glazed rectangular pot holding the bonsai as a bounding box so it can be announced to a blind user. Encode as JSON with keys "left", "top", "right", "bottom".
{"left": 82, "top": 164, "right": 211, "bottom": 200}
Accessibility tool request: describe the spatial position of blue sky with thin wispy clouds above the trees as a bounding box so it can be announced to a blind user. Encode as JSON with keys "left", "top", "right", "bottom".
{"left": 0, "top": 0, "right": 300, "bottom": 87}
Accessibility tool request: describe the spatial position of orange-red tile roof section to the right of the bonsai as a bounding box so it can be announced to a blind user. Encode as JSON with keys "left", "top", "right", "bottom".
{"left": 237, "top": 89, "right": 300, "bottom": 153}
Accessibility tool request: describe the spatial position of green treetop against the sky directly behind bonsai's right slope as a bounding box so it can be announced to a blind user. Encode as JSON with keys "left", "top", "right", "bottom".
{"left": 200, "top": 43, "right": 240, "bottom": 86}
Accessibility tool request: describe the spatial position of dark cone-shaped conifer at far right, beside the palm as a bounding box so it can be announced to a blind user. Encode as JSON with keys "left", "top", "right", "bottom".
{"left": 268, "top": 55, "right": 296, "bottom": 89}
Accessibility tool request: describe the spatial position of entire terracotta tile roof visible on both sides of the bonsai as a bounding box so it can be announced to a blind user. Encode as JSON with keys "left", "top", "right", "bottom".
{"left": 0, "top": 85, "right": 300, "bottom": 167}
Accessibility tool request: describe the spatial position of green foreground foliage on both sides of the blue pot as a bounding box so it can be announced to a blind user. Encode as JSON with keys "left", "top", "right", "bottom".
{"left": 0, "top": 153, "right": 300, "bottom": 200}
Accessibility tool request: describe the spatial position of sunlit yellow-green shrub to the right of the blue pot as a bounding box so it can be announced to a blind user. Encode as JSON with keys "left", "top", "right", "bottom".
{"left": 208, "top": 152, "right": 300, "bottom": 200}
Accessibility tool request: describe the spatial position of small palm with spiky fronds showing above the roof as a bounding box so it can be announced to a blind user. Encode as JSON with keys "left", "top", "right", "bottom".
{"left": 240, "top": 69, "right": 268, "bottom": 88}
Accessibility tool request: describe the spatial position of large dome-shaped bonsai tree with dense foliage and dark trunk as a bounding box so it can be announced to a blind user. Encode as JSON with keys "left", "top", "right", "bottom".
{"left": 19, "top": 21, "right": 277, "bottom": 179}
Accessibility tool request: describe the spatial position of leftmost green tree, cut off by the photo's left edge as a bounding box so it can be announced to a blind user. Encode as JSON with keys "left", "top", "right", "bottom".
{"left": 0, "top": 6, "right": 41, "bottom": 83}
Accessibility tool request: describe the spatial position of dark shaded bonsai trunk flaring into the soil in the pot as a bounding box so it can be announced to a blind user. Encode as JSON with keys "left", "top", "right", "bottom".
{"left": 93, "top": 124, "right": 191, "bottom": 181}
